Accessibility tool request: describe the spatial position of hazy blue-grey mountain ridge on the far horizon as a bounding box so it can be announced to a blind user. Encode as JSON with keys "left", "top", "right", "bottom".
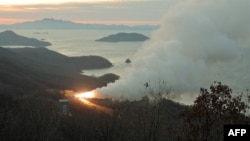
{"left": 0, "top": 18, "right": 158, "bottom": 30}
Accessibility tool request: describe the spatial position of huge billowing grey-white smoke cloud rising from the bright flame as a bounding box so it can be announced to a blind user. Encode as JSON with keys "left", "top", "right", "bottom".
{"left": 96, "top": 0, "right": 250, "bottom": 101}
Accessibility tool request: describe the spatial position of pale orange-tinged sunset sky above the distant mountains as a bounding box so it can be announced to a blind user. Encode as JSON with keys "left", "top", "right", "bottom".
{"left": 0, "top": 0, "right": 175, "bottom": 25}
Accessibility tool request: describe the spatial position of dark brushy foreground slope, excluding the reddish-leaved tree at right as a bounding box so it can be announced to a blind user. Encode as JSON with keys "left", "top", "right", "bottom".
{"left": 0, "top": 88, "right": 183, "bottom": 141}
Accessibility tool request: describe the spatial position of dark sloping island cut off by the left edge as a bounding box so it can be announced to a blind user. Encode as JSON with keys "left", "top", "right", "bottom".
{"left": 0, "top": 30, "right": 51, "bottom": 47}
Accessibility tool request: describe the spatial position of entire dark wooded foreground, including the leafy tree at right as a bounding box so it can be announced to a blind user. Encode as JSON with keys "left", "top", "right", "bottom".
{"left": 0, "top": 82, "right": 249, "bottom": 141}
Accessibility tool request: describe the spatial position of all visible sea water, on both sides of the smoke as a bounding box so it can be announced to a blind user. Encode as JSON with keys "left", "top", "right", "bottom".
{"left": 10, "top": 30, "right": 250, "bottom": 93}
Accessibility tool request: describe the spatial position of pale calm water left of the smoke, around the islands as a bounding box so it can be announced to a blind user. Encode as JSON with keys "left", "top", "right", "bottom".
{"left": 14, "top": 30, "right": 151, "bottom": 76}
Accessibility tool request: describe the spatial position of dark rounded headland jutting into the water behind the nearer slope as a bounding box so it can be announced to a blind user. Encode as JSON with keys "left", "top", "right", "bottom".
{"left": 9, "top": 48, "right": 112, "bottom": 74}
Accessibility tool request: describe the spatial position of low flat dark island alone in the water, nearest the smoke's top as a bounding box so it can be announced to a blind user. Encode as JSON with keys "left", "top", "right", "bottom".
{"left": 95, "top": 33, "right": 149, "bottom": 42}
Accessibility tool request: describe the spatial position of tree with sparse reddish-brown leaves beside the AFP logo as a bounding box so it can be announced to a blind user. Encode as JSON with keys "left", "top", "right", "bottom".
{"left": 181, "top": 82, "right": 248, "bottom": 141}
